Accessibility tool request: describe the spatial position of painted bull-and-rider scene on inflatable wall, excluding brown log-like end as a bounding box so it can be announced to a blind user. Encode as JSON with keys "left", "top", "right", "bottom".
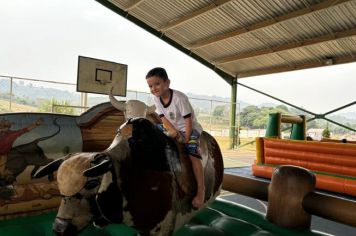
{"left": 0, "top": 113, "right": 82, "bottom": 216}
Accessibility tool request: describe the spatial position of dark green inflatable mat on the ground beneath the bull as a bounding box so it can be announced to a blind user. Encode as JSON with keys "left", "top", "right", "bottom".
{"left": 0, "top": 199, "right": 327, "bottom": 236}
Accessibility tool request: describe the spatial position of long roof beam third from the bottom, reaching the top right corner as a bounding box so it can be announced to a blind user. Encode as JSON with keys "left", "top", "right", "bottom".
{"left": 189, "top": 0, "right": 350, "bottom": 50}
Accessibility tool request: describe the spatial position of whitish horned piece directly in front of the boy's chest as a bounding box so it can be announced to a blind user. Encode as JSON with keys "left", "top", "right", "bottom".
{"left": 109, "top": 87, "right": 155, "bottom": 120}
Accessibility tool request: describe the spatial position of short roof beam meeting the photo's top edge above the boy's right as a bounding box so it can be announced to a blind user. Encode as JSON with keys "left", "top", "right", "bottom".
{"left": 159, "top": 0, "right": 232, "bottom": 32}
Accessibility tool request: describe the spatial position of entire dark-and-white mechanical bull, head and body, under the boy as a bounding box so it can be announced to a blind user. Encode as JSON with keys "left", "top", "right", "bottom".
{"left": 37, "top": 118, "right": 223, "bottom": 235}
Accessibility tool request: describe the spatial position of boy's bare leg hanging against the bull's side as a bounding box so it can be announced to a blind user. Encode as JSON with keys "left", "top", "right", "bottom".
{"left": 189, "top": 155, "right": 205, "bottom": 208}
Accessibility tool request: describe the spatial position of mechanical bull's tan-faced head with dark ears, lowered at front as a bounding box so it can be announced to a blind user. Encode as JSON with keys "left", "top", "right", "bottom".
{"left": 35, "top": 153, "right": 112, "bottom": 235}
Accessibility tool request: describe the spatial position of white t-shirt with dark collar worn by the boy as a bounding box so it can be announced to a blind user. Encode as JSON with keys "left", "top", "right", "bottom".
{"left": 153, "top": 89, "right": 203, "bottom": 134}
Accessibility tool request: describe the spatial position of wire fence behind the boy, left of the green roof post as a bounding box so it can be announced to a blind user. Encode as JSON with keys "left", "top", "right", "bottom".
{"left": 0, "top": 75, "right": 242, "bottom": 149}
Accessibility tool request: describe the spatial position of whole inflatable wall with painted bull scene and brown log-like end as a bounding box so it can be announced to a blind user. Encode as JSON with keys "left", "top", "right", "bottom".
{"left": 0, "top": 103, "right": 124, "bottom": 220}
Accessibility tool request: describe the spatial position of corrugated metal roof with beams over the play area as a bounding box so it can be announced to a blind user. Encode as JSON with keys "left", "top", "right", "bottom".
{"left": 97, "top": 0, "right": 356, "bottom": 84}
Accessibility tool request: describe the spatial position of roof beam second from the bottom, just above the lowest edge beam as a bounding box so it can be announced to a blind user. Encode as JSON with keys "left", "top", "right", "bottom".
{"left": 214, "top": 29, "right": 356, "bottom": 65}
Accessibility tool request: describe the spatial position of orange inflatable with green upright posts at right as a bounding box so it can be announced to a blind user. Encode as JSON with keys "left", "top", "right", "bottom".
{"left": 252, "top": 113, "right": 356, "bottom": 196}
